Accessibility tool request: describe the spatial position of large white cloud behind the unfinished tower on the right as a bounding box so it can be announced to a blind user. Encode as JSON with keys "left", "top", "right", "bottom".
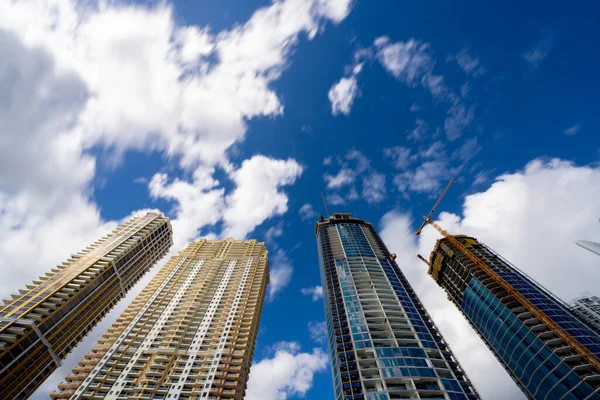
{"left": 381, "top": 160, "right": 600, "bottom": 400}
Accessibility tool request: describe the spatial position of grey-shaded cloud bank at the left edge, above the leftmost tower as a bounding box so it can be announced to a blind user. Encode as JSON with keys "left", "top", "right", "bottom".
{"left": 0, "top": 29, "right": 116, "bottom": 296}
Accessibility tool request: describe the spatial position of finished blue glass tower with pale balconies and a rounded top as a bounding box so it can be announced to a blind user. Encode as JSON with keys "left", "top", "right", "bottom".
{"left": 316, "top": 213, "right": 478, "bottom": 400}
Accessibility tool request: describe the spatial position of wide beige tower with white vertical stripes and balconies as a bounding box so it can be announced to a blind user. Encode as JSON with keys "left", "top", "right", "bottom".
{"left": 51, "top": 239, "right": 269, "bottom": 400}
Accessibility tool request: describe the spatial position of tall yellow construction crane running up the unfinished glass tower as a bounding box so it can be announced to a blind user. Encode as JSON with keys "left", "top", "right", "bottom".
{"left": 416, "top": 179, "right": 600, "bottom": 372}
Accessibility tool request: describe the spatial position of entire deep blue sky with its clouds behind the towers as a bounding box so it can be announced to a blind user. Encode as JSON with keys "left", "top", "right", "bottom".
{"left": 0, "top": 0, "right": 600, "bottom": 400}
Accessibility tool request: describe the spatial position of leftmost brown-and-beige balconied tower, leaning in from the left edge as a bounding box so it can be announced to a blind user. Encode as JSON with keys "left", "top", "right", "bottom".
{"left": 0, "top": 213, "right": 173, "bottom": 400}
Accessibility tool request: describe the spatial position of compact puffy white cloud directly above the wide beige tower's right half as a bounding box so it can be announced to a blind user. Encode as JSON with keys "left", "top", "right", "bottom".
{"left": 223, "top": 155, "right": 303, "bottom": 239}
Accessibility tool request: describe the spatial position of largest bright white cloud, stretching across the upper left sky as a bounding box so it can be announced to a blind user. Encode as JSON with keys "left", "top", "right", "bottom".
{"left": 0, "top": 0, "right": 350, "bottom": 167}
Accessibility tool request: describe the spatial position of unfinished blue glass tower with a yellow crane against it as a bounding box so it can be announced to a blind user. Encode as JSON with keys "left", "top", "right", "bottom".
{"left": 429, "top": 235, "right": 600, "bottom": 400}
